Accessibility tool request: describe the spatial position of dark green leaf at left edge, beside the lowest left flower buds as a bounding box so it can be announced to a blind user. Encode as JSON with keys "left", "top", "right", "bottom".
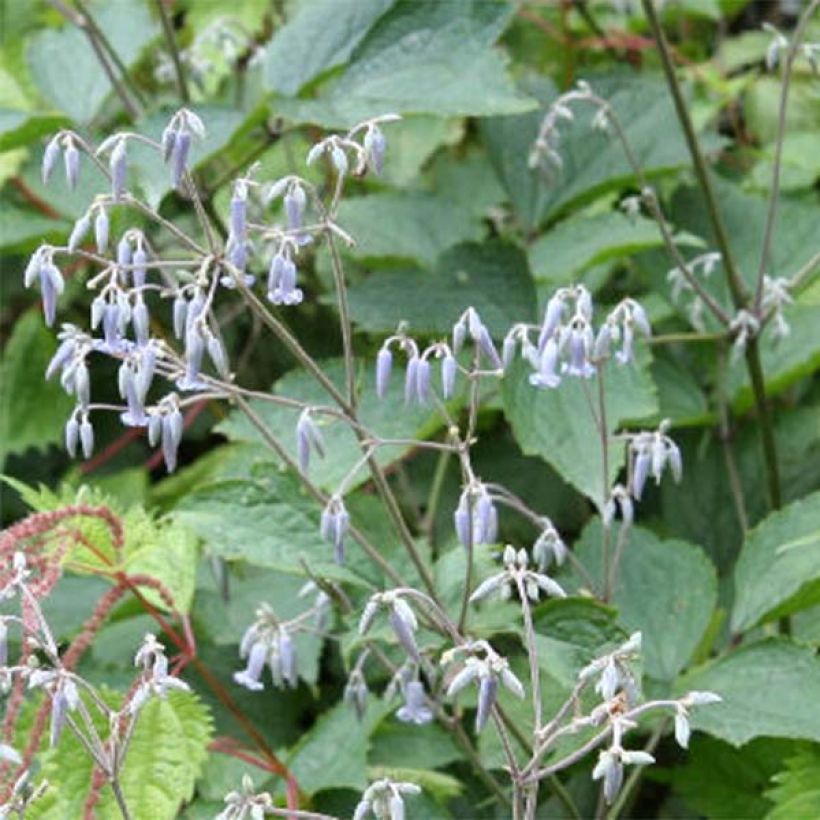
{"left": 0, "top": 310, "right": 74, "bottom": 465}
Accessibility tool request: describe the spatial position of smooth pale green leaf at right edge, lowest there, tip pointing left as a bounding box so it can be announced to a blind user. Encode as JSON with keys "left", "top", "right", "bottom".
{"left": 676, "top": 638, "right": 820, "bottom": 746}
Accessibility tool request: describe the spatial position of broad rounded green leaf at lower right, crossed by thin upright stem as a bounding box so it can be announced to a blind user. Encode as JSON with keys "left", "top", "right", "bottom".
{"left": 575, "top": 519, "right": 717, "bottom": 681}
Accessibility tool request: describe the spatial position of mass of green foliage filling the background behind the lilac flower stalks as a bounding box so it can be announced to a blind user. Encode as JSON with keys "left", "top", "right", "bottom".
{"left": 0, "top": 0, "right": 820, "bottom": 818}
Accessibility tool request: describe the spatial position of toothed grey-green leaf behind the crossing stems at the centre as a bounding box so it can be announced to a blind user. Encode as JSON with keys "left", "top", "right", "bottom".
{"left": 217, "top": 359, "right": 441, "bottom": 496}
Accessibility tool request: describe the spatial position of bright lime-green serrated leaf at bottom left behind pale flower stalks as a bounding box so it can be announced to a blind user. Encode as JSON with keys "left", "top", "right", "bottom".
{"left": 26, "top": 692, "right": 213, "bottom": 820}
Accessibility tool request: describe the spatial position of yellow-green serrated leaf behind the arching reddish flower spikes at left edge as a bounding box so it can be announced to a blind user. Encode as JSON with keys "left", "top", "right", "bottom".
{"left": 3, "top": 476, "right": 198, "bottom": 612}
